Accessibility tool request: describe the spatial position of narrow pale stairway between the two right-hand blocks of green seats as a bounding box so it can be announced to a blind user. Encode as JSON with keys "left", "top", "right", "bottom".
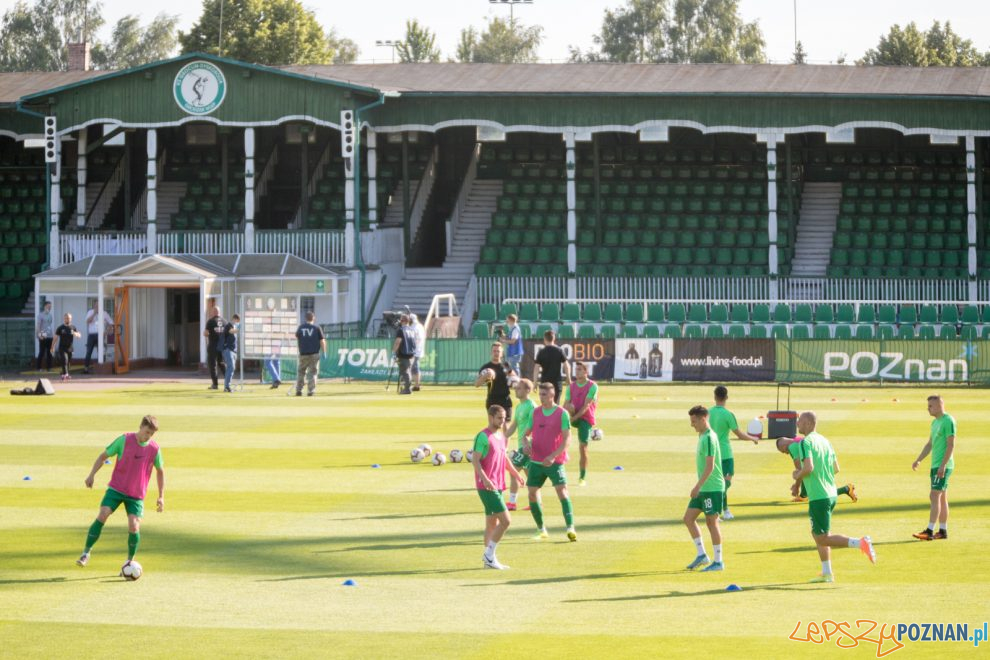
{"left": 791, "top": 183, "right": 842, "bottom": 277}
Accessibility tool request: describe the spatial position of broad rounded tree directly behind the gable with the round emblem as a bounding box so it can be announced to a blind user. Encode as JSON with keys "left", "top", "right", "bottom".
{"left": 179, "top": 0, "right": 357, "bottom": 65}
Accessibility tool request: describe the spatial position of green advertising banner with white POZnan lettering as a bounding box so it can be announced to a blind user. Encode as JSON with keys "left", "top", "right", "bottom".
{"left": 777, "top": 339, "right": 990, "bottom": 383}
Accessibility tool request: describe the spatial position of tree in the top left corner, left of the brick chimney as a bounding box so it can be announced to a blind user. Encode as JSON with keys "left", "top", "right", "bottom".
{"left": 0, "top": 0, "right": 103, "bottom": 71}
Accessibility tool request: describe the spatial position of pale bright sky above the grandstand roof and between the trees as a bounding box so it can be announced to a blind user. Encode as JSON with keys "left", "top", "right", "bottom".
{"left": 95, "top": 0, "right": 990, "bottom": 63}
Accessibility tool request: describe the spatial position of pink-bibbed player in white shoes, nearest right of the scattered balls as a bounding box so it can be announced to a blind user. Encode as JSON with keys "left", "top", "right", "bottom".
{"left": 471, "top": 405, "right": 519, "bottom": 570}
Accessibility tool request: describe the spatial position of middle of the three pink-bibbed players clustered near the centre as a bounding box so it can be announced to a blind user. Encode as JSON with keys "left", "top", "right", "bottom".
{"left": 524, "top": 383, "right": 577, "bottom": 541}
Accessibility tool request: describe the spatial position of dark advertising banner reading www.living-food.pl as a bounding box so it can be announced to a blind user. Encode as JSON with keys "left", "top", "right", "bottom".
{"left": 673, "top": 339, "right": 777, "bottom": 383}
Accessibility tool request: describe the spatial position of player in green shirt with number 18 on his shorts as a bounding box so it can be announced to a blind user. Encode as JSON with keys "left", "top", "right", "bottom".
{"left": 684, "top": 406, "right": 725, "bottom": 571}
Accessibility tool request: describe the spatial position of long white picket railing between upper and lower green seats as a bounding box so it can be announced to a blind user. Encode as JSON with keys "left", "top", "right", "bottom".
{"left": 477, "top": 277, "right": 990, "bottom": 306}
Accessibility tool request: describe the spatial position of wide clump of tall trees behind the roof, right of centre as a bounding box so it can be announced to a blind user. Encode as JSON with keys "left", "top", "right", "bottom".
{"left": 571, "top": 0, "right": 766, "bottom": 63}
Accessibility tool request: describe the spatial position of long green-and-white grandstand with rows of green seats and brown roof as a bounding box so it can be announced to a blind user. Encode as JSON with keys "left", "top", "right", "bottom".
{"left": 0, "top": 54, "right": 990, "bottom": 372}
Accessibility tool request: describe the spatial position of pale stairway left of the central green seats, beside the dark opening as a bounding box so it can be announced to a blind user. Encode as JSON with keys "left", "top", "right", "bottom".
{"left": 392, "top": 179, "right": 502, "bottom": 318}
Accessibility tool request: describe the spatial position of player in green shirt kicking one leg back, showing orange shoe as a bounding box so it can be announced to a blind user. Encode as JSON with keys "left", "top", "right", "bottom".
{"left": 777, "top": 411, "right": 877, "bottom": 582}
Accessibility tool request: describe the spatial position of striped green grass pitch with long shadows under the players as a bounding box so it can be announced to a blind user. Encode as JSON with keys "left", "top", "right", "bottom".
{"left": 0, "top": 381, "right": 990, "bottom": 658}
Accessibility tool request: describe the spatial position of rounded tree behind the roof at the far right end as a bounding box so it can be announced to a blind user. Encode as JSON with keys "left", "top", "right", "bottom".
{"left": 857, "top": 21, "right": 990, "bottom": 66}
